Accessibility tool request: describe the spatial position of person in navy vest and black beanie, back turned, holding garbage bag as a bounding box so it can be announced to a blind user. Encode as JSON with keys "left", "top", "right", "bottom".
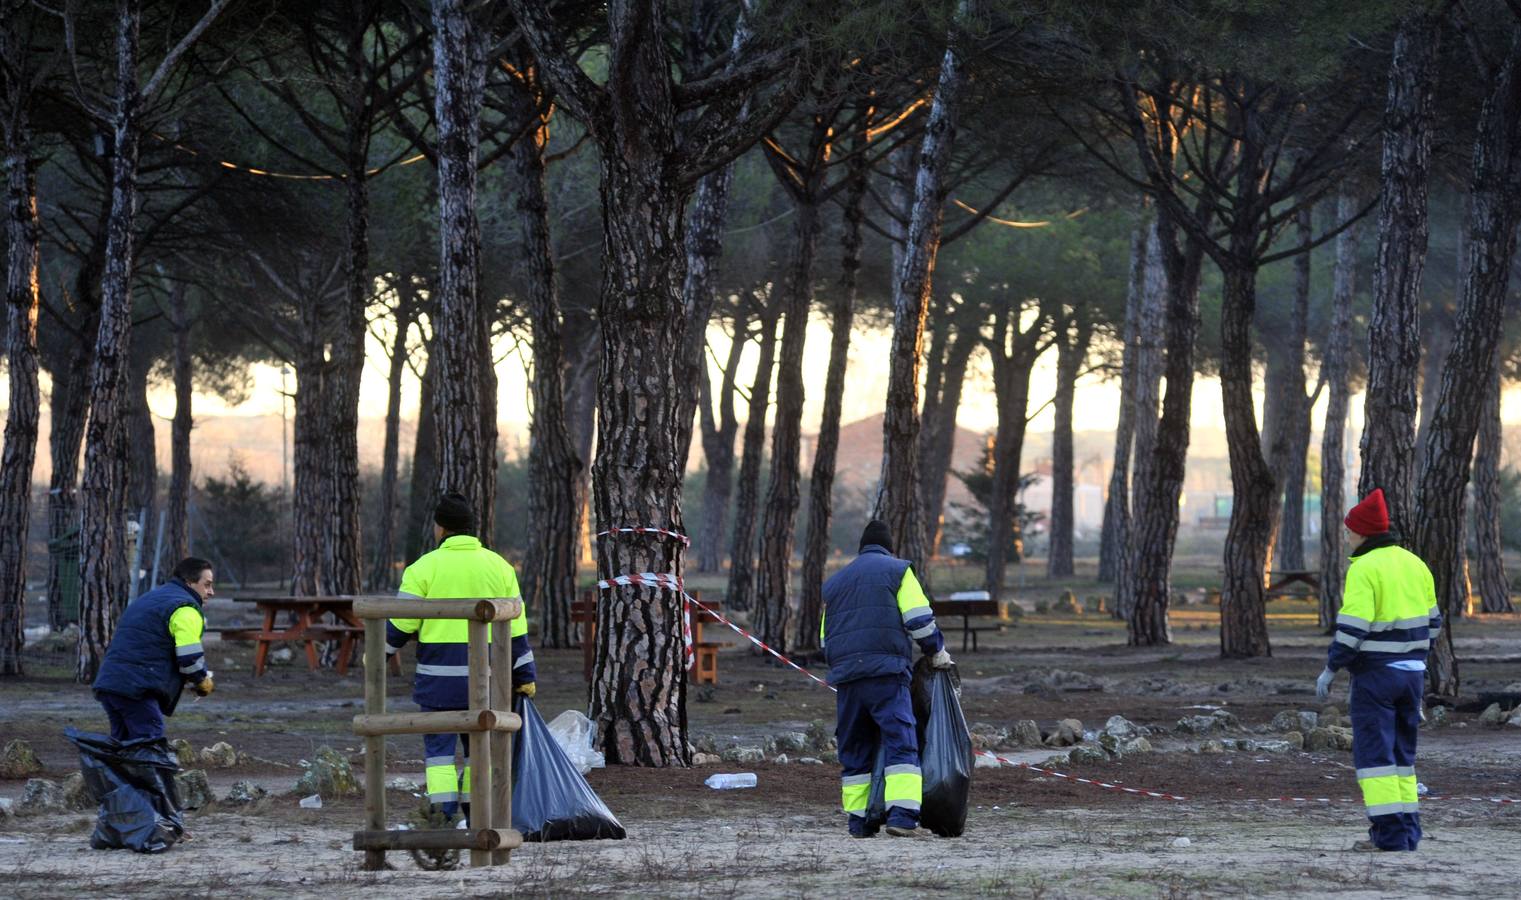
{"left": 818, "top": 518, "right": 951, "bottom": 838}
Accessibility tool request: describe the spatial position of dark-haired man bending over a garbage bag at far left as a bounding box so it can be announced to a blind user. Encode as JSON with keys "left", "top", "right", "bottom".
{"left": 91, "top": 556, "right": 216, "bottom": 740}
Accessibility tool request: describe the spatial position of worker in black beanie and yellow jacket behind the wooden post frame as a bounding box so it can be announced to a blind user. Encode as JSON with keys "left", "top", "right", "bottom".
{"left": 385, "top": 493, "right": 535, "bottom": 824}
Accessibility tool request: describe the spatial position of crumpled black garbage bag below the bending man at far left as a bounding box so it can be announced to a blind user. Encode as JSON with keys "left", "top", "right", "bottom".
{"left": 64, "top": 728, "right": 184, "bottom": 853}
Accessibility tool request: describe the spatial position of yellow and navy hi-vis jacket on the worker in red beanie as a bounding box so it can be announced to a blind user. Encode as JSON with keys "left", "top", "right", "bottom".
{"left": 1326, "top": 534, "right": 1442, "bottom": 675}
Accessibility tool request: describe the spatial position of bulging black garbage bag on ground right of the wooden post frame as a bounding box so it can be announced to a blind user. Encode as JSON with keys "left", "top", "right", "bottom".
{"left": 513, "top": 695, "right": 625, "bottom": 841}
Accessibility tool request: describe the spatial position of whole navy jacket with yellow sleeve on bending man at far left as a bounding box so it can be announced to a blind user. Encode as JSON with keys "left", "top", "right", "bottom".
{"left": 91, "top": 578, "right": 205, "bottom": 715}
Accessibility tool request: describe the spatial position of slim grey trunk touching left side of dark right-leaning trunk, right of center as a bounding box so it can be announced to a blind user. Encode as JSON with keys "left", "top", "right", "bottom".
{"left": 1115, "top": 225, "right": 1170, "bottom": 622}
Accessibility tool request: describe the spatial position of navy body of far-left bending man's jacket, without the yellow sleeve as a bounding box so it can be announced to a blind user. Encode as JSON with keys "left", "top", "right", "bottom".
{"left": 93, "top": 579, "right": 201, "bottom": 715}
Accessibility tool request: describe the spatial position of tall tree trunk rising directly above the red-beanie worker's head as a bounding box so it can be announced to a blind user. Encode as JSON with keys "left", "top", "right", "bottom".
{"left": 1357, "top": 12, "right": 1440, "bottom": 535}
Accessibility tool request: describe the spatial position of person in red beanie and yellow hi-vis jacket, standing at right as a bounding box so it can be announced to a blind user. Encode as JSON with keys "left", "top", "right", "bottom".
{"left": 1316, "top": 488, "right": 1442, "bottom": 851}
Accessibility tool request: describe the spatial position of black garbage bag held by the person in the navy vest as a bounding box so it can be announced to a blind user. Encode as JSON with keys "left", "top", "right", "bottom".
{"left": 865, "top": 657, "right": 973, "bottom": 838}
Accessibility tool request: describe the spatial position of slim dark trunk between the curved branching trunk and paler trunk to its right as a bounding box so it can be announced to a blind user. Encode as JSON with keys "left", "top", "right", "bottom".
{"left": 1264, "top": 207, "right": 1313, "bottom": 570}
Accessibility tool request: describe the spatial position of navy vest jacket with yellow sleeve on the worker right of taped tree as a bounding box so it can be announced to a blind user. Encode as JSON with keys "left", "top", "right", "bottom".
{"left": 820, "top": 544, "right": 941, "bottom": 684}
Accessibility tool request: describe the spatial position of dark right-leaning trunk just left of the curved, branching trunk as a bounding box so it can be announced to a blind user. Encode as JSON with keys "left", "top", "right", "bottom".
{"left": 1121, "top": 211, "right": 1203, "bottom": 646}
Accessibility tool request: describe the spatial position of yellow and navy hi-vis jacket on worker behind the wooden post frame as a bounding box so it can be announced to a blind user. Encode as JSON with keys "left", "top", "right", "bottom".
{"left": 386, "top": 535, "right": 535, "bottom": 710}
